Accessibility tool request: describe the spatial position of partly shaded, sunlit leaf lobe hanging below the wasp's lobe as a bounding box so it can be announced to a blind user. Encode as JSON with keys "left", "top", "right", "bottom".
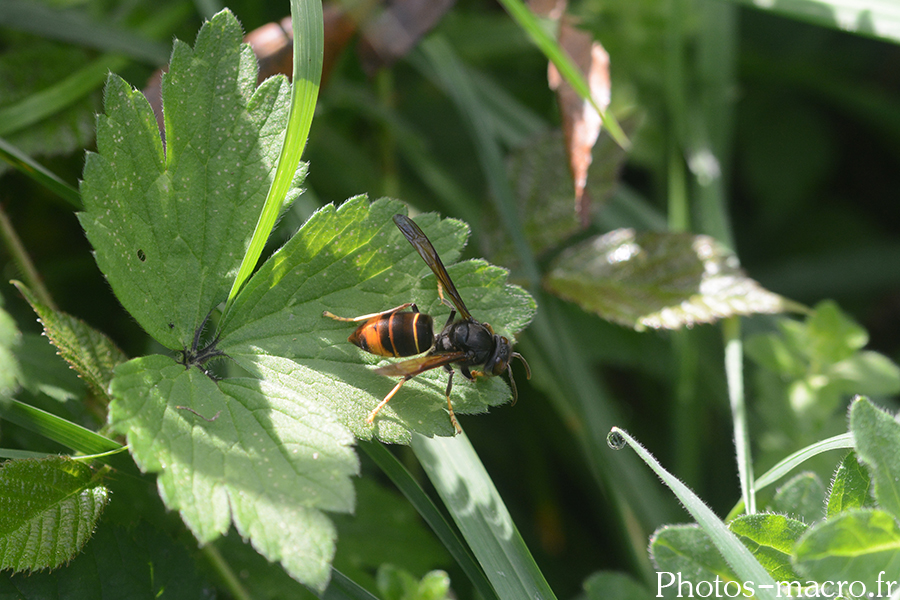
{"left": 109, "top": 355, "right": 358, "bottom": 589}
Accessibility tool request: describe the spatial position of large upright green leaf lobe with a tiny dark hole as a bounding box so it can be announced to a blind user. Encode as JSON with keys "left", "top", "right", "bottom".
{"left": 79, "top": 10, "right": 296, "bottom": 349}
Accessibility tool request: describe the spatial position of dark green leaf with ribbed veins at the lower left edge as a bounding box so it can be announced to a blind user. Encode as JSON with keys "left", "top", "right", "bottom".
{"left": 0, "top": 456, "right": 109, "bottom": 572}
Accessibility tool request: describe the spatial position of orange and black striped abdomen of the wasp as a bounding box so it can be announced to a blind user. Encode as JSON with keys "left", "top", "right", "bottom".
{"left": 347, "top": 312, "right": 434, "bottom": 356}
